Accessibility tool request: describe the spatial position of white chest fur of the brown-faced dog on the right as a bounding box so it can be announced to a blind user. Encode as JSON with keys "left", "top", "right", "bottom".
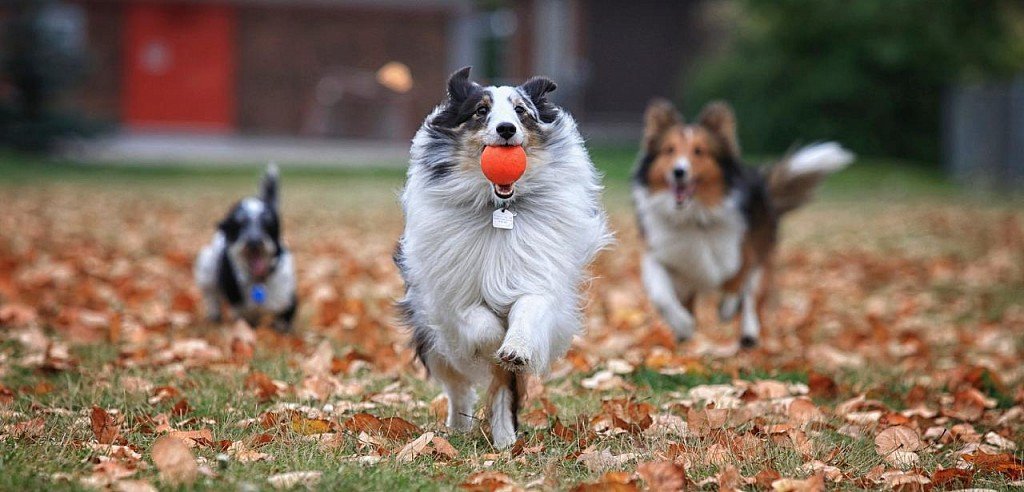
{"left": 638, "top": 194, "right": 746, "bottom": 292}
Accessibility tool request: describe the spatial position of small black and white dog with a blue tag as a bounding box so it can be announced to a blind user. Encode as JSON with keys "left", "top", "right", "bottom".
{"left": 195, "top": 164, "right": 297, "bottom": 331}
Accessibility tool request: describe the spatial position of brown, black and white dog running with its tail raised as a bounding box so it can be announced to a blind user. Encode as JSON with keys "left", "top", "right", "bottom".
{"left": 633, "top": 100, "right": 853, "bottom": 347}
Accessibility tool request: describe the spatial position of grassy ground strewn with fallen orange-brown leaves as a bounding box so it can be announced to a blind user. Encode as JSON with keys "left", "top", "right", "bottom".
{"left": 0, "top": 158, "right": 1024, "bottom": 490}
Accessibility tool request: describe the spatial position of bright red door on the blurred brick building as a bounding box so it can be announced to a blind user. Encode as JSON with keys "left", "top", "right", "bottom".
{"left": 122, "top": 2, "right": 234, "bottom": 131}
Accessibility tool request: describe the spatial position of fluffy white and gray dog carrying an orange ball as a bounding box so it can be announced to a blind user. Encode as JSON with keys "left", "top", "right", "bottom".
{"left": 395, "top": 68, "right": 610, "bottom": 448}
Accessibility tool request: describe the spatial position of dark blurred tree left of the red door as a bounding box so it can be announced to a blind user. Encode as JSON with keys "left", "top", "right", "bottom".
{"left": 0, "top": 0, "right": 94, "bottom": 150}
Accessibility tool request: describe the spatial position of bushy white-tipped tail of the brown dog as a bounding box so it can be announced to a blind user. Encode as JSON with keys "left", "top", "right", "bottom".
{"left": 766, "top": 141, "right": 854, "bottom": 214}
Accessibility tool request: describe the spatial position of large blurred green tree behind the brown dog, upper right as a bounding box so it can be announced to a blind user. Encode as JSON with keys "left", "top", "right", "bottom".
{"left": 684, "top": 0, "right": 1024, "bottom": 162}
